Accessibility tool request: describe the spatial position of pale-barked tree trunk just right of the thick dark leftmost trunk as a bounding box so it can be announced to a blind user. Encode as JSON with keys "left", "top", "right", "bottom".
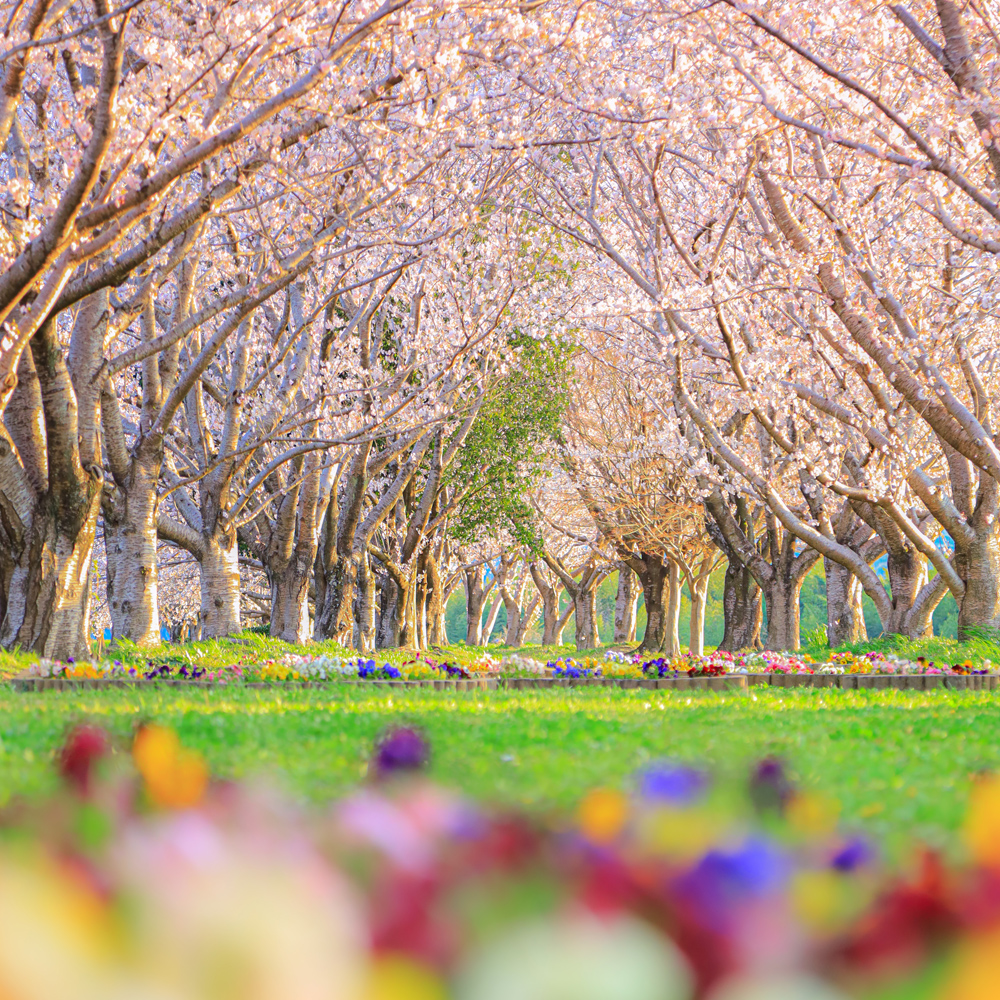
{"left": 104, "top": 458, "right": 161, "bottom": 646}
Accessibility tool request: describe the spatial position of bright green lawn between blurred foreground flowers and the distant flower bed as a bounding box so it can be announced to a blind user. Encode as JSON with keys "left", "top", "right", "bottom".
{"left": 0, "top": 686, "right": 1000, "bottom": 851}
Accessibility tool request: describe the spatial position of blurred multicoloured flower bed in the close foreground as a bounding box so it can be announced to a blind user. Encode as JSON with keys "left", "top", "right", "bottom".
{"left": 0, "top": 725, "right": 1000, "bottom": 1000}
